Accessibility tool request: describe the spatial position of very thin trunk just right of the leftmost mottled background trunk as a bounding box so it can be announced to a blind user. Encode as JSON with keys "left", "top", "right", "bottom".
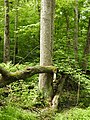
{"left": 13, "top": 0, "right": 19, "bottom": 64}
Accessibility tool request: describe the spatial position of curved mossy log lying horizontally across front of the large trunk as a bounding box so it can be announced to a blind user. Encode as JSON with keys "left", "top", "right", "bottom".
{"left": 0, "top": 66, "right": 57, "bottom": 87}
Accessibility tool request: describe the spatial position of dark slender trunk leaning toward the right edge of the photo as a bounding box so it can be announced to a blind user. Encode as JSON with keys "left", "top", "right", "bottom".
{"left": 82, "top": 17, "right": 90, "bottom": 71}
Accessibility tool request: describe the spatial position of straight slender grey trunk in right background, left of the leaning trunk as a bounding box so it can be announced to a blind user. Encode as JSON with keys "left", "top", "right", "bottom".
{"left": 73, "top": 0, "right": 78, "bottom": 61}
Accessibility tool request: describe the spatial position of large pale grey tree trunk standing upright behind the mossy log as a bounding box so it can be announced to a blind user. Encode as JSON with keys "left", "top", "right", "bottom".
{"left": 39, "top": 0, "right": 53, "bottom": 103}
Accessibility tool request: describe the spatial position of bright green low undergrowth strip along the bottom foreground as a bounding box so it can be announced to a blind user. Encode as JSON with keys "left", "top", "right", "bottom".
{"left": 0, "top": 105, "right": 90, "bottom": 120}
